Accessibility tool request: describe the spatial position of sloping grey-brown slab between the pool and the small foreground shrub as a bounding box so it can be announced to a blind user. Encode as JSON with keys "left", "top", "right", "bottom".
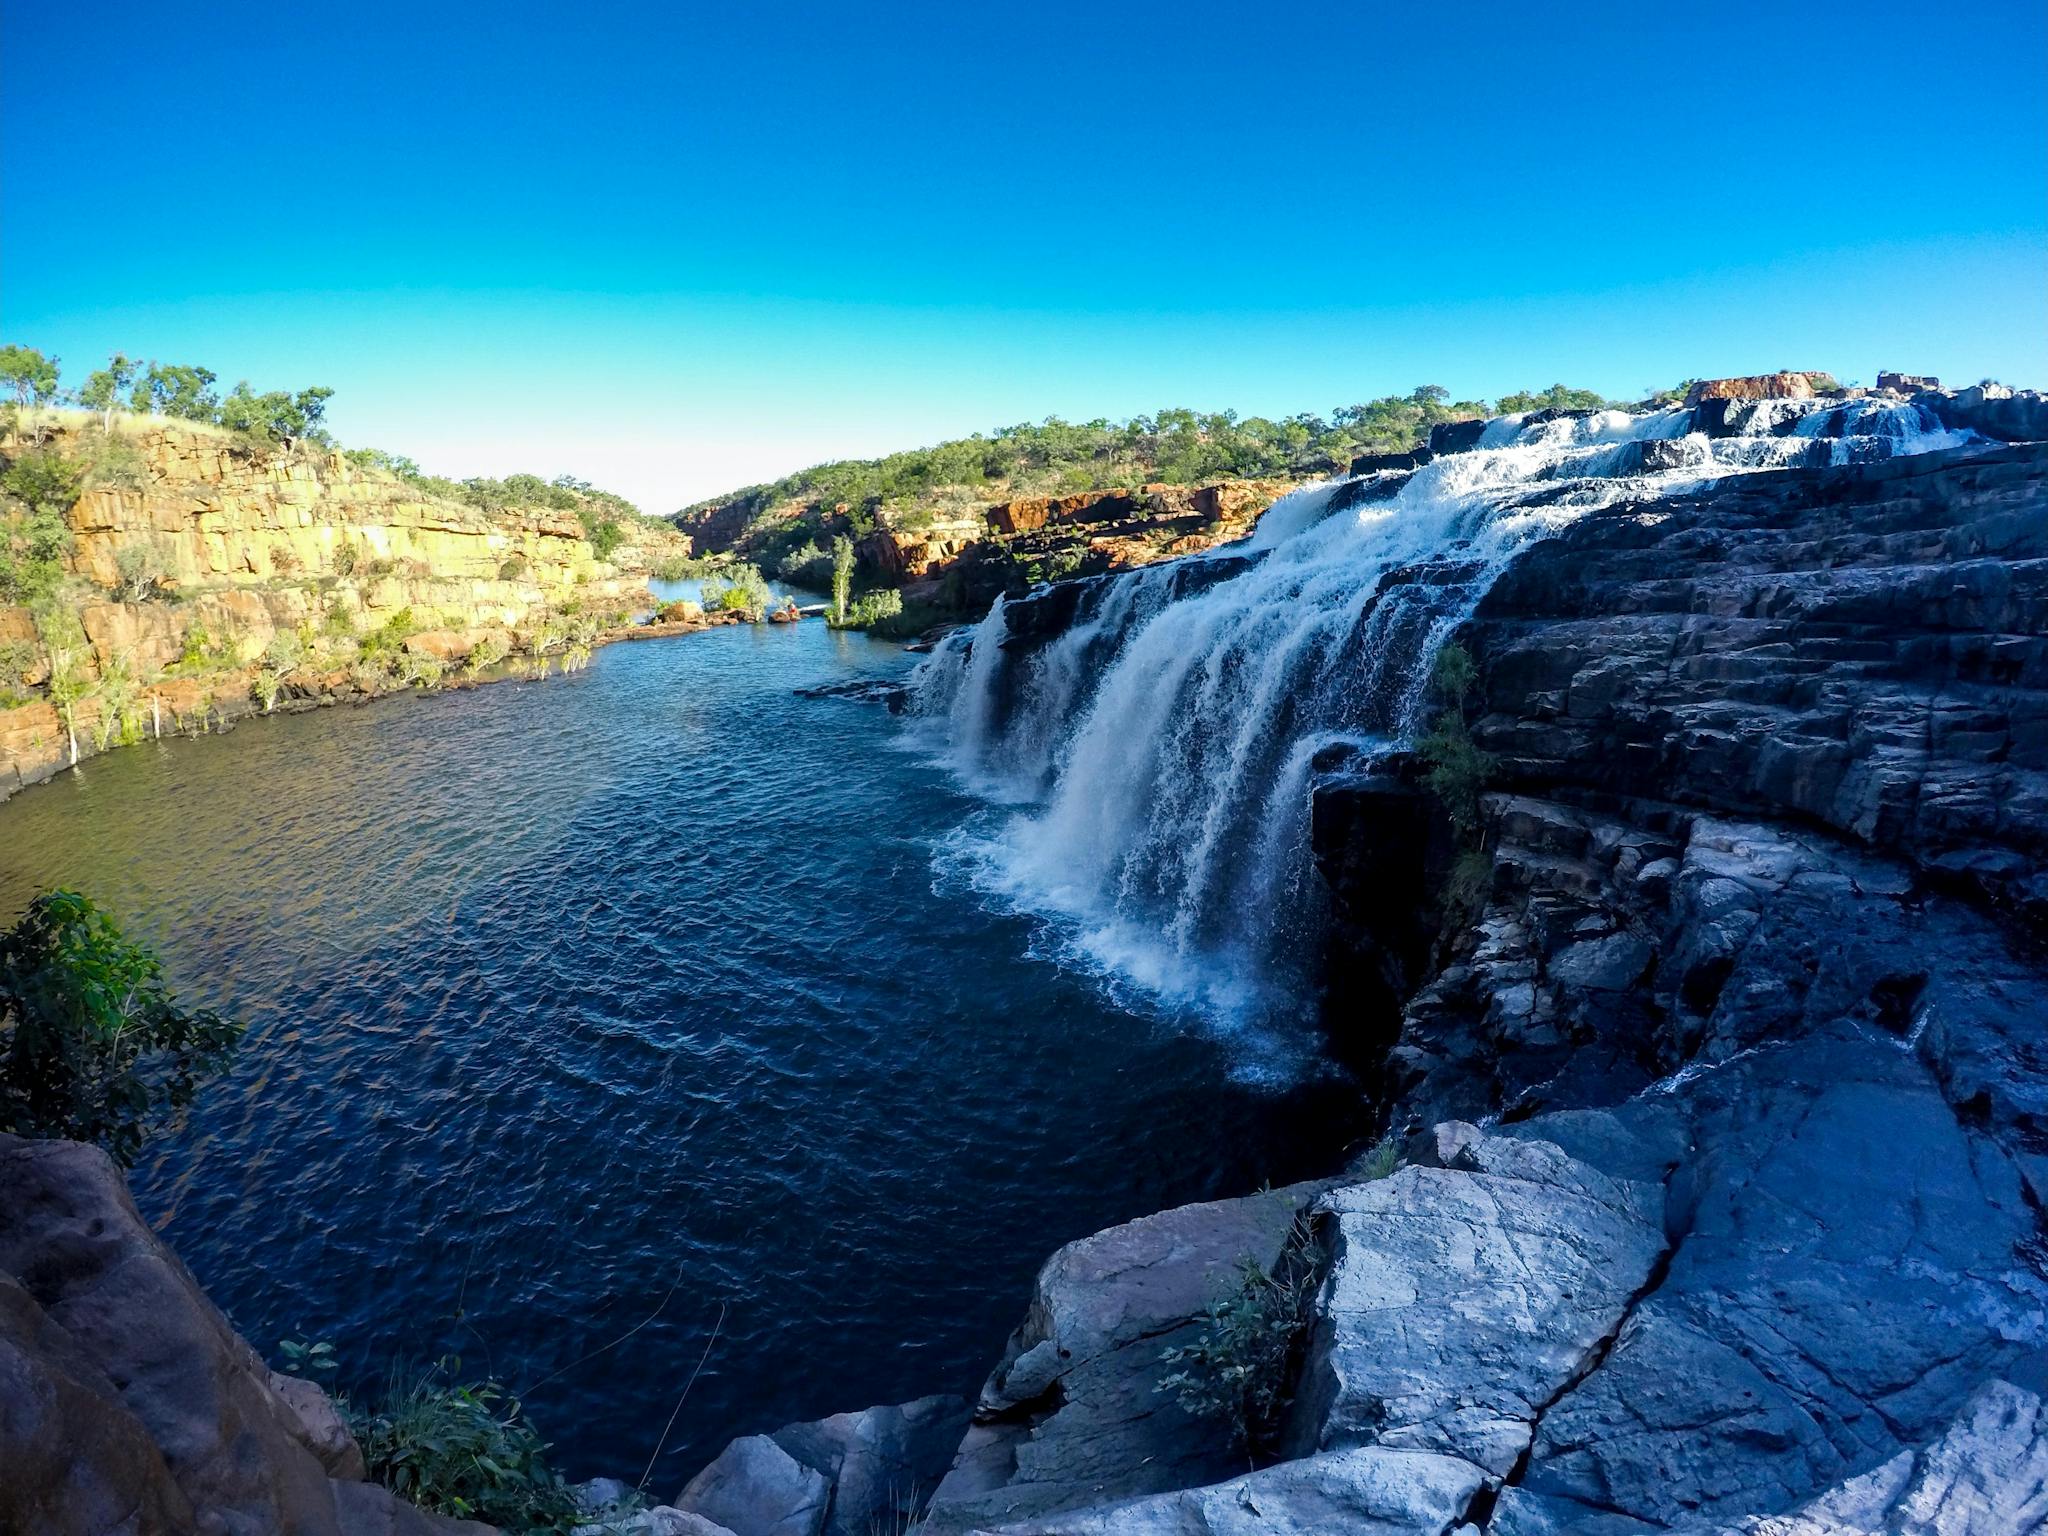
{"left": 924, "top": 1184, "right": 1325, "bottom": 1536}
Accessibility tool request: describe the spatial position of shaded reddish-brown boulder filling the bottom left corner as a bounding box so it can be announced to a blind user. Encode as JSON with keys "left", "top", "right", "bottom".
{"left": 0, "top": 1137, "right": 487, "bottom": 1536}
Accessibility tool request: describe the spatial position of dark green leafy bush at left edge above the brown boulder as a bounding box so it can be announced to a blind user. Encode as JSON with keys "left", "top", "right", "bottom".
{"left": 0, "top": 891, "right": 242, "bottom": 1167}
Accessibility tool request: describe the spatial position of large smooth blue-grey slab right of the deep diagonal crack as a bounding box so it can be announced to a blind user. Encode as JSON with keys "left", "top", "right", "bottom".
{"left": 1522, "top": 1024, "right": 2048, "bottom": 1530}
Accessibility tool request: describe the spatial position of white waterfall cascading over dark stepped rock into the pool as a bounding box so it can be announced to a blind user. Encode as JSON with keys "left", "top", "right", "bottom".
{"left": 915, "top": 401, "right": 1968, "bottom": 1048}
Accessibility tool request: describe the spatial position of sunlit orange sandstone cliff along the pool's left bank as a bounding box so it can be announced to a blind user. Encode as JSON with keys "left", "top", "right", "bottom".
{"left": 0, "top": 414, "right": 686, "bottom": 799}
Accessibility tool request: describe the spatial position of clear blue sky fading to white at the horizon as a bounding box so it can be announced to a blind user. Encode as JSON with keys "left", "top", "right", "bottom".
{"left": 0, "top": 0, "right": 2048, "bottom": 510}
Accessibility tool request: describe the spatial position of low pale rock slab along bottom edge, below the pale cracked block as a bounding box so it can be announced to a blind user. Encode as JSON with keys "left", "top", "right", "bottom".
{"left": 966, "top": 1446, "right": 1485, "bottom": 1536}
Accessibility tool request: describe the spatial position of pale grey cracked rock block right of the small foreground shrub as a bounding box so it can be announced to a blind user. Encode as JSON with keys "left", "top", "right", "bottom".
{"left": 1294, "top": 1124, "right": 1665, "bottom": 1477}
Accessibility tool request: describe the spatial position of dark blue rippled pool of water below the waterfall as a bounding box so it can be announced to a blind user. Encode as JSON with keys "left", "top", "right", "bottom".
{"left": 0, "top": 623, "right": 1358, "bottom": 1495}
